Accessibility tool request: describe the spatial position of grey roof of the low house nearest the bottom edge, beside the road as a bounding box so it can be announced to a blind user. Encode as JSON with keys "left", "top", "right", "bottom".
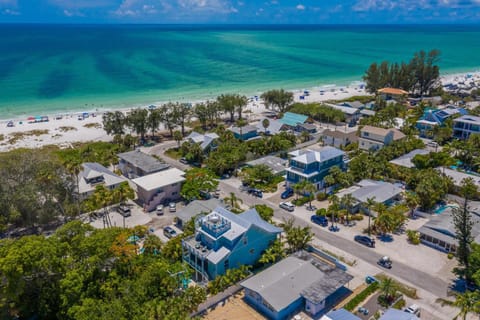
{"left": 241, "top": 252, "right": 353, "bottom": 311}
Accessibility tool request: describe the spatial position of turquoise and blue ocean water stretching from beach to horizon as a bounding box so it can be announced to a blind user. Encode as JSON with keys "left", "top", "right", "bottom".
{"left": 0, "top": 25, "right": 480, "bottom": 119}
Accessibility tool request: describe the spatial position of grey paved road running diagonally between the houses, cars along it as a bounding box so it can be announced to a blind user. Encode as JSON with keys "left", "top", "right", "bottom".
{"left": 220, "top": 180, "right": 449, "bottom": 297}
